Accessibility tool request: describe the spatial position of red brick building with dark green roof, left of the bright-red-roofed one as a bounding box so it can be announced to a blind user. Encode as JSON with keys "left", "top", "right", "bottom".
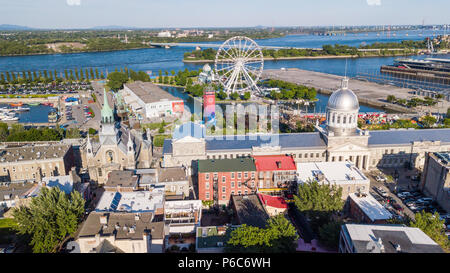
{"left": 198, "top": 157, "right": 257, "bottom": 205}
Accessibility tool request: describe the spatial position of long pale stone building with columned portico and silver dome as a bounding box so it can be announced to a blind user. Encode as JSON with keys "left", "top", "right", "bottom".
{"left": 163, "top": 76, "right": 450, "bottom": 174}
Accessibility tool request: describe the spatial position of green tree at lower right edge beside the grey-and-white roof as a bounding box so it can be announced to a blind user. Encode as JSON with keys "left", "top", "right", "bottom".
{"left": 409, "top": 211, "right": 450, "bottom": 250}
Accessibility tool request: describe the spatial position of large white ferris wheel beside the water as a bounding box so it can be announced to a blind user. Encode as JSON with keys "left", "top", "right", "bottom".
{"left": 214, "top": 36, "right": 264, "bottom": 95}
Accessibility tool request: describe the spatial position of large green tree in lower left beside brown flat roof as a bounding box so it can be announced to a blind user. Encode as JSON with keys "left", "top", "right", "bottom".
{"left": 13, "top": 187, "right": 85, "bottom": 253}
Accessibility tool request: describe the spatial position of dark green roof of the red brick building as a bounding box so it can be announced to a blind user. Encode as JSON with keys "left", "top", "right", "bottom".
{"left": 198, "top": 157, "right": 256, "bottom": 173}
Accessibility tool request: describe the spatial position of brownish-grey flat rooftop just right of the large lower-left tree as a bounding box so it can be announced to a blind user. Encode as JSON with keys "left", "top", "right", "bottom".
{"left": 78, "top": 212, "right": 164, "bottom": 239}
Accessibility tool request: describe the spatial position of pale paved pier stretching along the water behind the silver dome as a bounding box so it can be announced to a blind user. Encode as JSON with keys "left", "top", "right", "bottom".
{"left": 262, "top": 68, "right": 450, "bottom": 113}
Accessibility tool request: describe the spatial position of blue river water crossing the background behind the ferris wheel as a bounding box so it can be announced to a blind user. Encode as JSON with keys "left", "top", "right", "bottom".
{"left": 0, "top": 30, "right": 450, "bottom": 114}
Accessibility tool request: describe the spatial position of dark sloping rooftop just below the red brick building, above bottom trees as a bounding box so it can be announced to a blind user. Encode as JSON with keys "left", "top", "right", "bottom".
{"left": 231, "top": 194, "right": 269, "bottom": 228}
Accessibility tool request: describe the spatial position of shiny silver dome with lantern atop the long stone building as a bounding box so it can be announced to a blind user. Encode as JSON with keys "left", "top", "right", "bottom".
{"left": 327, "top": 79, "right": 359, "bottom": 111}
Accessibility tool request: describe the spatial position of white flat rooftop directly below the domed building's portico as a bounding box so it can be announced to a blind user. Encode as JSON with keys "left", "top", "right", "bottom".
{"left": 297, "top": 162, "right": 370, "bottom": 184}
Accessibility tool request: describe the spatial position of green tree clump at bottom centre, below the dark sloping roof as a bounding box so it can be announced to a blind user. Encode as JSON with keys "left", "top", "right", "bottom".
{"left": 225, "top": 215, "right": 298, "bottom": 253}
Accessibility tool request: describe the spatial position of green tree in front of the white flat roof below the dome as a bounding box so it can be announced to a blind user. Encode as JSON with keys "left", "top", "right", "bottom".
{"left": 294, "top": 180, "right": 344, "bottom": 232}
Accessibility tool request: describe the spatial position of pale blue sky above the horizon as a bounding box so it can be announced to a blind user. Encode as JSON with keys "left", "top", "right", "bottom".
{"left": 0, "top": 0, "right": 450, "bottom": 28}
